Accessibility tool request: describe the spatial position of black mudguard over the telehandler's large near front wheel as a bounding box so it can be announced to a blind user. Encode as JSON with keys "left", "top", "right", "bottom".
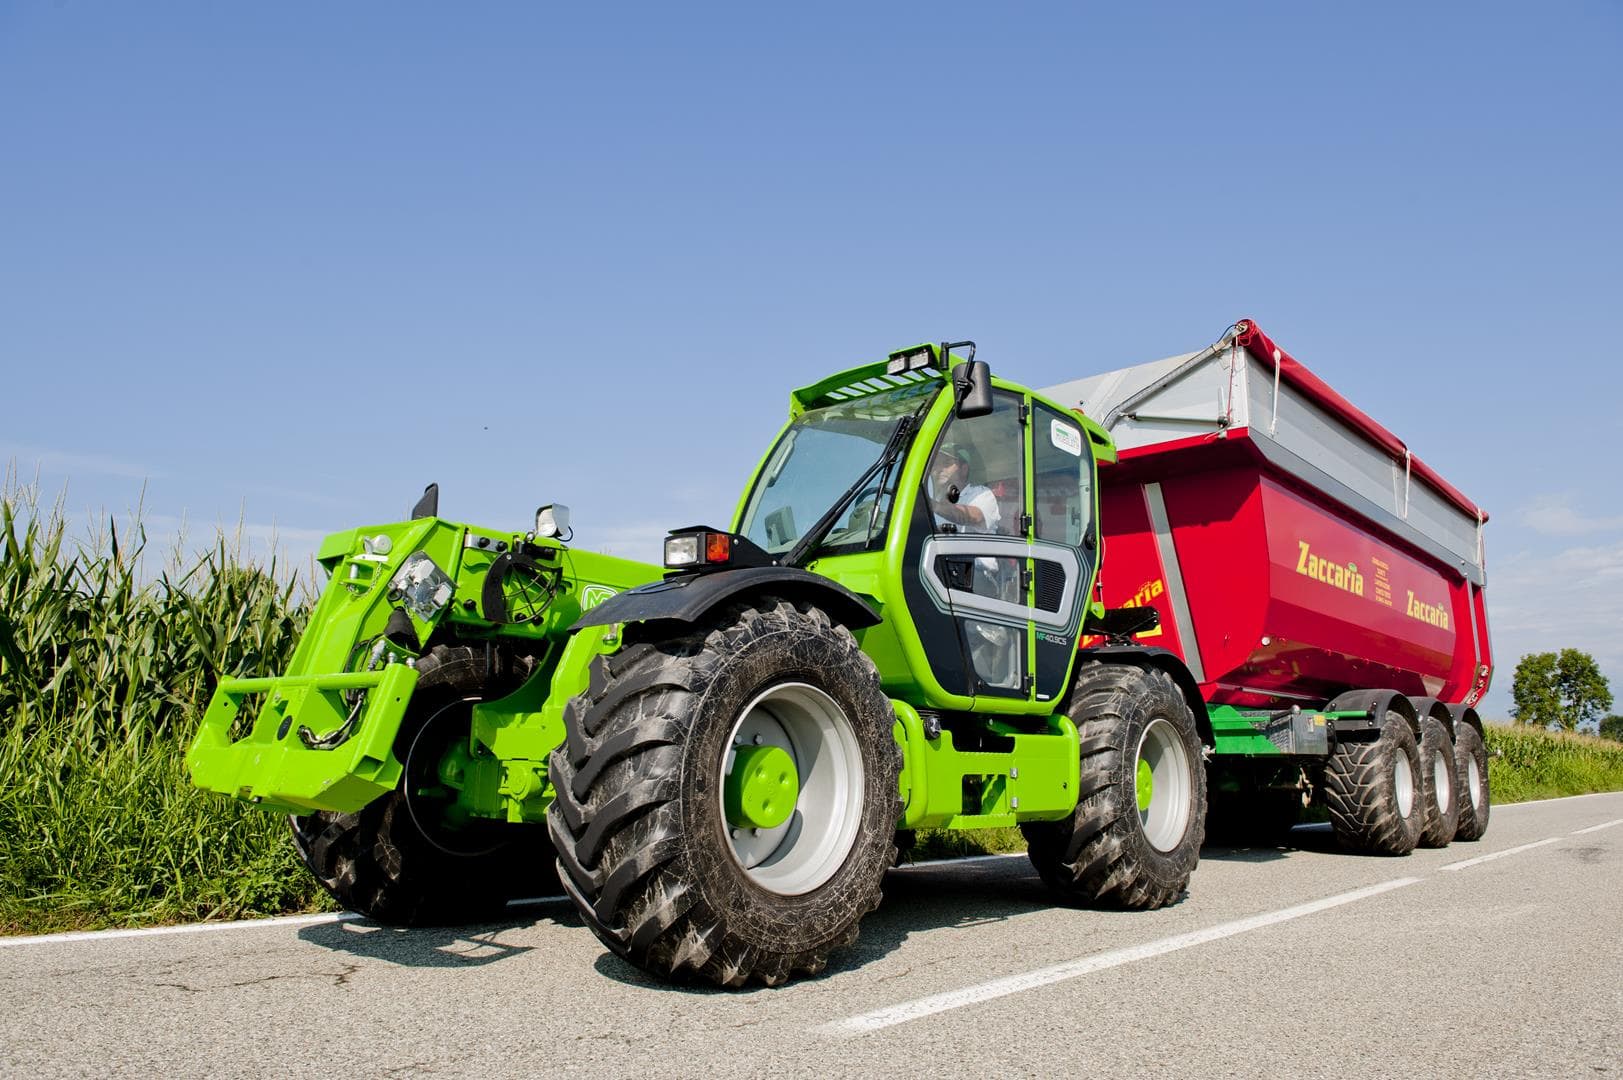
{"left": 575, "top": 567, "right": 880, "bottom": 630}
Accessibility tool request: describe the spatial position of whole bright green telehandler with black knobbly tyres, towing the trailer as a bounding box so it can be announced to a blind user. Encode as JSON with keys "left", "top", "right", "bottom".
{"left": 192, "top": 341, "right": 1214, "bottom": 986}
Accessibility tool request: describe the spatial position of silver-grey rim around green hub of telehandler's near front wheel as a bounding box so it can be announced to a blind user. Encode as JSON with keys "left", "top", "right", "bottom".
{"left": 716, "top": 682, "right": 863, "bottom": 896}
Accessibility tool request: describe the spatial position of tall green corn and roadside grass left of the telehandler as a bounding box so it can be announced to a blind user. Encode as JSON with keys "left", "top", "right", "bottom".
{"left": 0, "top": 486, "right": 326, "bottom": 932}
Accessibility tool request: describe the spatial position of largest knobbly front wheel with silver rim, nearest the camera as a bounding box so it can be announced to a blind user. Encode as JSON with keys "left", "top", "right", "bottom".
{"left": 547, "top": 599, "right": 901, "bottom": 986}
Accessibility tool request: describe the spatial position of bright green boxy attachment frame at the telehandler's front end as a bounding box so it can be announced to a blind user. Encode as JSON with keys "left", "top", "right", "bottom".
{"left": 187, "top": 664, "right": 417, "bottom": 814}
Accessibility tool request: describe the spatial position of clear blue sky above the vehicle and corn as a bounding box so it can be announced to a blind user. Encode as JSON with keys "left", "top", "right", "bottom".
{"left": 0, "top": 0, "right": 1623, "bottom": 715}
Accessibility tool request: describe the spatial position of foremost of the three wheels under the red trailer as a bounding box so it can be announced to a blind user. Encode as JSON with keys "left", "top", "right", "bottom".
{"left": 1324, "top": 711, "right": 1425, "bottom": 854}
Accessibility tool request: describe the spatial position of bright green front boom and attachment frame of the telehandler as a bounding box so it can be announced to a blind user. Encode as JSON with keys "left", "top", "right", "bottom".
{"left": 187, "top": 518, "right": 661, "bottom": 820}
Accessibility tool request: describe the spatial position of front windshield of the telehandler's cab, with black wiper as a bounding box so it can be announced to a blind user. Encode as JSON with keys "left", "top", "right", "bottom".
{"left": 738, "top": 380, "right": 941, "bottom": 555}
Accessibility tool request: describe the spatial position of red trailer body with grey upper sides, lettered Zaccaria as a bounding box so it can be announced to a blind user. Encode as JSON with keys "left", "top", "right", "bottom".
{"left": 1047, "top": 316, "right": 1493, "bottom": 708}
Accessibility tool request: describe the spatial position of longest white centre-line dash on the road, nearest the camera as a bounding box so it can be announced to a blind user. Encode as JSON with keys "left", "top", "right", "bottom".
{"left": 815, "top": 877, "right": 1420, "bottom": 1036}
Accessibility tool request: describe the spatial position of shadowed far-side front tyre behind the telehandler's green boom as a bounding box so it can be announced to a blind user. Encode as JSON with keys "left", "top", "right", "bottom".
{"left": 289, "top": 646, "right": 557, "bottom": 926}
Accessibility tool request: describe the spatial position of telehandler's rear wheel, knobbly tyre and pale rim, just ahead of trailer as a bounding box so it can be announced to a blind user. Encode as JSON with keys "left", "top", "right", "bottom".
{"left": 1021, "top": 663, "right": 1206, "bottom": 909}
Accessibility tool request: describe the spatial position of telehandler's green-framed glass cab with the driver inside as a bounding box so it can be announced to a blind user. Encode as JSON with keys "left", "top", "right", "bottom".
{"left": 691, "top": 343, "right": 1113, "bottom": 715}
